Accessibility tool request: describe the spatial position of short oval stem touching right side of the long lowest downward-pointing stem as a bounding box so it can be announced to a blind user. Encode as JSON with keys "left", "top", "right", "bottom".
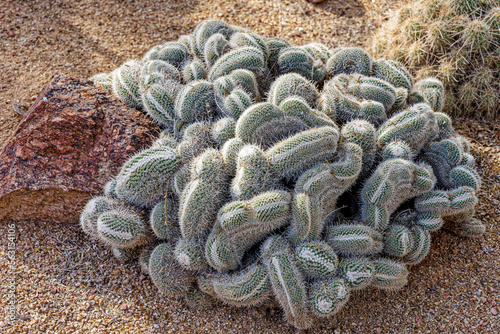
{"left": 295, "top": 241, "right": 339, "bottom": 278}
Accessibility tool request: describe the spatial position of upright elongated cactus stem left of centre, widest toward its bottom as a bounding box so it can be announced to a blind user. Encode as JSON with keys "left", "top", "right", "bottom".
{"left": 179, "top": 149, "right": 227, "bottom": 240}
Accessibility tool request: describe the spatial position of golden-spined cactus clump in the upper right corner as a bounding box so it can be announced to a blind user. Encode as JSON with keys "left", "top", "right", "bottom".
{"left": 372, "top": 0, "right": 500, "bottom": 118}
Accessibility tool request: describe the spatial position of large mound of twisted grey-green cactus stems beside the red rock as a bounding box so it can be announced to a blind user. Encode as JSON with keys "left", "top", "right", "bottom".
{"left": 81, "top": 20, "right": 484, "bottom": 328}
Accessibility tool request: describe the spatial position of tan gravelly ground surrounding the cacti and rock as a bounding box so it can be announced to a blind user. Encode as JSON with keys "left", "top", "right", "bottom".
{"left": 0, "top": 0, "right": 500, "bottom": 334}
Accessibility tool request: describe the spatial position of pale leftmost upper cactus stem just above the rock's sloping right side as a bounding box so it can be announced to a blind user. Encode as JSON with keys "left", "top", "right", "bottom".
{"left": 112, "top": 60, "right": 142, "bottom": 109}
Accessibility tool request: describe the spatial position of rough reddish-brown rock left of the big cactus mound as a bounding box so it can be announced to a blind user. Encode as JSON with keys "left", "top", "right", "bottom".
{"left": 0, "top": 75, "right": 159, "bottom": 223}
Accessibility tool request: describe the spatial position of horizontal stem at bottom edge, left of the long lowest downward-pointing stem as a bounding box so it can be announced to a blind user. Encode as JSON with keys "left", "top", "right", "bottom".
{"left": 199, "top": 264, "right": 272, "bottom": 307}
